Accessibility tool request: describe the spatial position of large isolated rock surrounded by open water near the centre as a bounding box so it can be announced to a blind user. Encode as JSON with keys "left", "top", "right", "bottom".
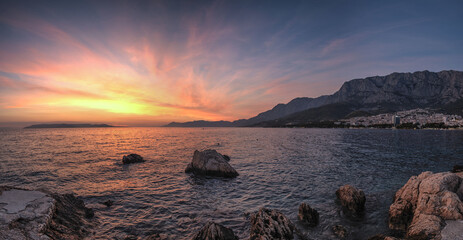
{"left": 185, "top": 149, "right": 238, "bottom": 178}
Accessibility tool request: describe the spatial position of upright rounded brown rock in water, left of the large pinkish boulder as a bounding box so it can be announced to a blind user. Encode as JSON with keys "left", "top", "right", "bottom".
{"left": 336, "top": 185, "right": 366, "bottom": 216}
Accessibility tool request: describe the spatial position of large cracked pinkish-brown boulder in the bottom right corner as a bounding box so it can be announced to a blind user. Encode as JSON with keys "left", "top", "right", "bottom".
{"left": 389, "top": 172, "right": 463, "bottom": 239}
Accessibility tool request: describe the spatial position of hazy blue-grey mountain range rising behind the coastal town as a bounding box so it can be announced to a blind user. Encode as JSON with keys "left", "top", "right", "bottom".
{"left": 166, "top": 70, "right": 463, "bottom": 127}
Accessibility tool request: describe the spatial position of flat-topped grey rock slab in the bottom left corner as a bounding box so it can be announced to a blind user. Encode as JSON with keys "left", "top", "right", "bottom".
{"left": 0, "top": 187, "right": 93, "bottom": 240}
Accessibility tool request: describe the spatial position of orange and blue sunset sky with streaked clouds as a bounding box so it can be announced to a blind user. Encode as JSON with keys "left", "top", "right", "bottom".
{"left": 0, "top": 0, "right": 463, "bottom": 126}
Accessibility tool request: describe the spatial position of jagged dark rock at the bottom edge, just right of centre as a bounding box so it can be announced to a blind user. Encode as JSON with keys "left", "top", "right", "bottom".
{"left": 250, "top": 208, "right": 295, "bottom": 240}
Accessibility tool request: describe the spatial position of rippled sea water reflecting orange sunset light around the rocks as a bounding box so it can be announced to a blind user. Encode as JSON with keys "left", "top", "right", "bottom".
{"left": 0, "top": 128, "right": 463, "bottom": 239}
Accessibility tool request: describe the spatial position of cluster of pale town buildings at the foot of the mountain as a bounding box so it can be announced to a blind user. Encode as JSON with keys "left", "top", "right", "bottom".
{"left": 341, "top": 108, "right": 463, "bottom": 127}
